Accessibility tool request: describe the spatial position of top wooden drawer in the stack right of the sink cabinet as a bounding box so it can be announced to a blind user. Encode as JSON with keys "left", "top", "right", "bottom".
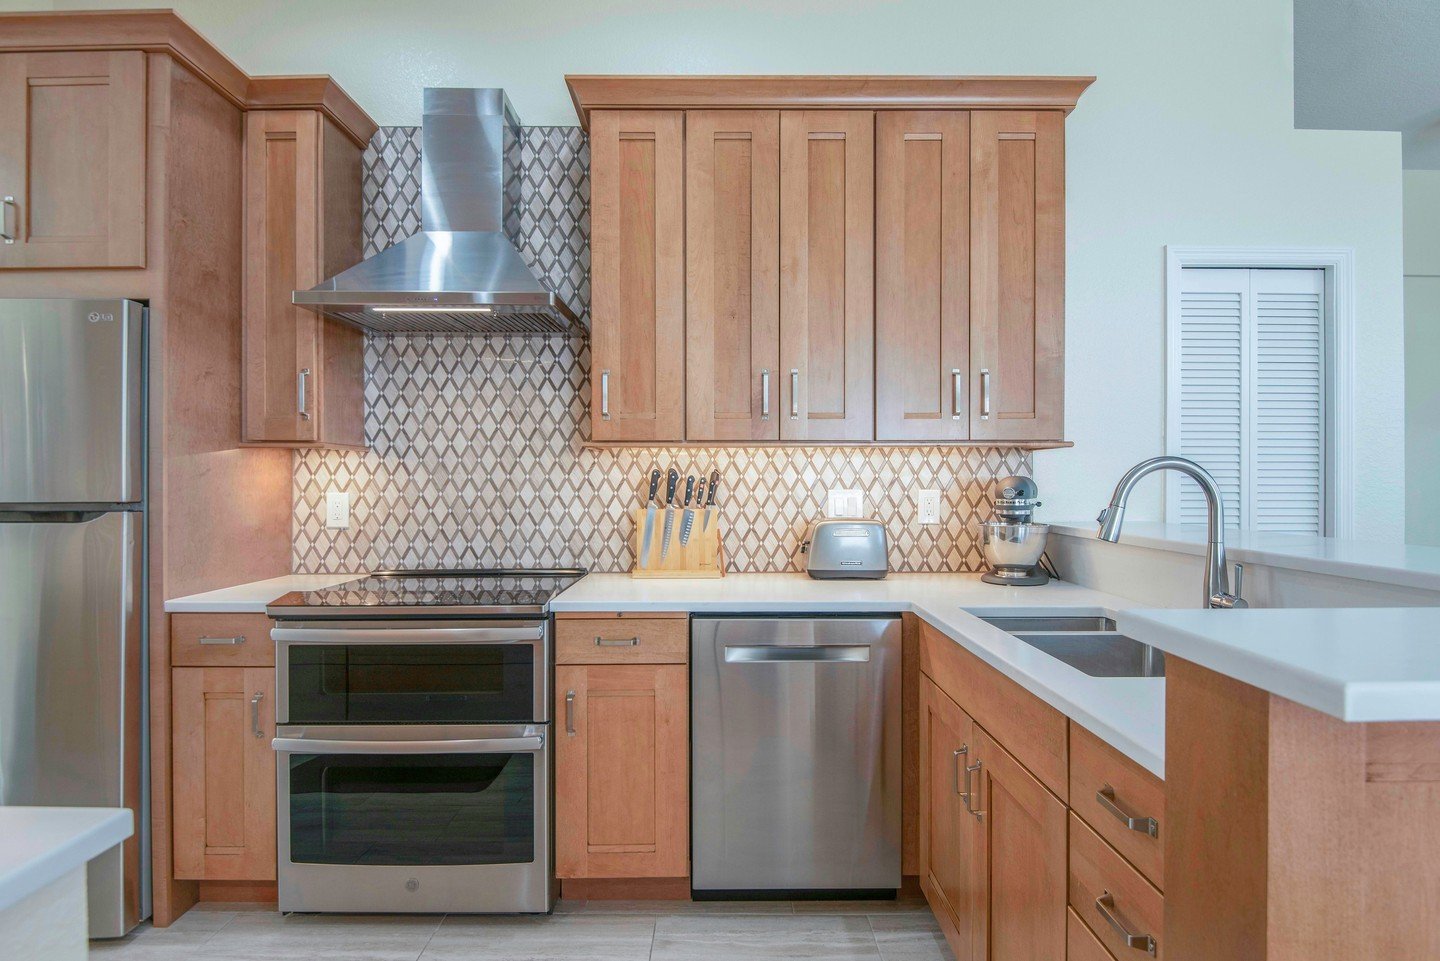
{"left": 1070, "top": 723, "right": 1165, "bottom": 890}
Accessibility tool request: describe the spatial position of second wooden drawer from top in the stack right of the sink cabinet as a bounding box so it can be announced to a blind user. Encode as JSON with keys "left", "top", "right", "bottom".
{"left": 1070, "top": 813, "right": 1165, "bottom": 961}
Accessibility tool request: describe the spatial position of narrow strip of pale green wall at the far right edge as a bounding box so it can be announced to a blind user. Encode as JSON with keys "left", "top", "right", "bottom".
{"left": 1405, "top": 170, "right": 1440, "bottom": 546}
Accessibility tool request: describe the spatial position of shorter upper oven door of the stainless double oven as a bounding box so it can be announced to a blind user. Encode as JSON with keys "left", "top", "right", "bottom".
{"left": 271, "top": 621, "right": 550, "bottom": 725}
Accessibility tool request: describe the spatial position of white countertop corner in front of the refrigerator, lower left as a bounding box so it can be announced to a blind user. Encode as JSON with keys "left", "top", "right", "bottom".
{"left": 0, "top": 807, "right": 135, "bottom": 911}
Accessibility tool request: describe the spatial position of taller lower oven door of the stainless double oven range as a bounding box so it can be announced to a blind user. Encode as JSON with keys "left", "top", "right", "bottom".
{"left": 274, "top": 725, "right": 554, "bottom": 912}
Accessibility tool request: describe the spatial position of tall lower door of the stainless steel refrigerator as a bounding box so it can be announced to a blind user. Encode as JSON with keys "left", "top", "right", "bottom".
{"left": 0, "top": 511, "right": 144, "bottom": 938}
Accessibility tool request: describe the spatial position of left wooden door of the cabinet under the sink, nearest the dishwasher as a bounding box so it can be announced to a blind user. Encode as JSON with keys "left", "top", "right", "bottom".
{"left": 920, "top": 674, "right": 984, "bottom": 961}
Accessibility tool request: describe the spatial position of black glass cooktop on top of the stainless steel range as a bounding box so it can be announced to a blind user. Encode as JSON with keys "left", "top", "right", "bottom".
{"left": 266, "top": 568, "right": 585, "bottom": 618}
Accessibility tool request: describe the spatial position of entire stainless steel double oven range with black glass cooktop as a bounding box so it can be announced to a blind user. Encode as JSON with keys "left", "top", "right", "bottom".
{"left": 268, "top": 571, "right": 583, "bottom": 912}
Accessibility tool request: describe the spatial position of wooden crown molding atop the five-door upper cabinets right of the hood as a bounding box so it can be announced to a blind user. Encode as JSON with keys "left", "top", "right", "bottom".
{"left": 564, "top": 73, "right": 1094, "bottom": 130}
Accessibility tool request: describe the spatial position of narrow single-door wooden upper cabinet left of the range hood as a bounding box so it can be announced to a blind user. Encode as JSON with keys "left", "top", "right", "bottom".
{"left": 243, "top": 109, "right": 364, "bottom": 447}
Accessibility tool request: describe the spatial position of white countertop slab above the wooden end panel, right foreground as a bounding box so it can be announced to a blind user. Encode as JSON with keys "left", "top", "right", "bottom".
{"left": 1117, "top": 608, "right": 1440, "bottom": 722}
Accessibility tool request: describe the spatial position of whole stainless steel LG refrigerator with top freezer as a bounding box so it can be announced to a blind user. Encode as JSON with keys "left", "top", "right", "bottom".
{"left": 0, "top": 300, "right": 150, "bottom": 938}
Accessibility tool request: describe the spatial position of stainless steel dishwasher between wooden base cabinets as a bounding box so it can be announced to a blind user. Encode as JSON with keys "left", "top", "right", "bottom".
{"left": 690, "top": 617, "right": 900, "bottom": 899}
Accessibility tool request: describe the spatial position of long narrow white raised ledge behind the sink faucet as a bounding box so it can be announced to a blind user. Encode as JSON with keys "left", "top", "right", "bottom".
{"left": 1050, "top": 520, "right": 1440, "bottom": 591}
